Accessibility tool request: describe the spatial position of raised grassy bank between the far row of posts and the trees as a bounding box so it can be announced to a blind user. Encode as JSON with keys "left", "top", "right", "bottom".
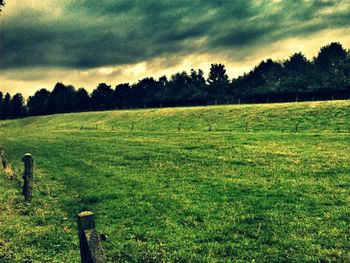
{"left": 0, "top": 101, "right": 350, "bottom": 133}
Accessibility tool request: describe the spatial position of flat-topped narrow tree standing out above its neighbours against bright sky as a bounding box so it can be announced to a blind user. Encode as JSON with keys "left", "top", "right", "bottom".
{"left": 207, "top": 64, "right": 230, "bottom": 102}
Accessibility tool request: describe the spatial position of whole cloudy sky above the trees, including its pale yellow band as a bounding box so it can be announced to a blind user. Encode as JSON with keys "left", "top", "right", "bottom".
{"left": 0, "top": 0, "right": 350, "bottom": 97}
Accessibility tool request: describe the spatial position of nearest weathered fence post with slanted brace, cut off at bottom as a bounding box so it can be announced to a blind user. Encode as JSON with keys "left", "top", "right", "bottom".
{"left": 78, "top": 211, "right": 106, "bottom": 263}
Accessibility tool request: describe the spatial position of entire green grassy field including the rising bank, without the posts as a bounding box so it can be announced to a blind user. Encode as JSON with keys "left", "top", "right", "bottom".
{"left": 0, "top": 101, "right": 350, "bottom": 262}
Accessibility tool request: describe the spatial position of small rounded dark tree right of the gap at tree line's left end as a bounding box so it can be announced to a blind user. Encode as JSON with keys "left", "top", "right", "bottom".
{"left": 27, "top": 89, "right": 50, "bottom": 116}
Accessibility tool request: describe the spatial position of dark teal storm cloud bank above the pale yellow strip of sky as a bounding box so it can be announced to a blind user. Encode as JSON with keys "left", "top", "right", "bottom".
{"left": 0, "top": 0, "right": 350, "bottom": 69}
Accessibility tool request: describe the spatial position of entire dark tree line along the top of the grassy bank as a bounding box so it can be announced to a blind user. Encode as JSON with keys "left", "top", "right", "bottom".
{"left": 0, "top": 42, "right": 350, "bottom": 119}
